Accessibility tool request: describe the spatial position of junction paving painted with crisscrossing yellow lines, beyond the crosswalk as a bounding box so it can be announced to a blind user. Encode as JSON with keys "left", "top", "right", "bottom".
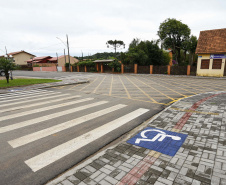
{"left": 52, "top": 74, "right": 226, "bottom": 105}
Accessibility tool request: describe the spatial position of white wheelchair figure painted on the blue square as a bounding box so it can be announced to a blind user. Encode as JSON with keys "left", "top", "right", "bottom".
{"left": 135, "top": 129, "right": 181, "bottom": 144}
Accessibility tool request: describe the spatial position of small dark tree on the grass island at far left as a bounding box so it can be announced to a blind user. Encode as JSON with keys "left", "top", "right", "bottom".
{"left": 0, "top": 57, "right": 16, "bottom": 83}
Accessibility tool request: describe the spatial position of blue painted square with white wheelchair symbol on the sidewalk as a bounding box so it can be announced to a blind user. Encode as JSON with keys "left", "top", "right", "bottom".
{"left": 127, "top": 127, "right": 187, "bottom": 156}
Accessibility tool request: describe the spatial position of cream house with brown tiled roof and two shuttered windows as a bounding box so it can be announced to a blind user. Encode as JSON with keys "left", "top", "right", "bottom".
{"left": 196, "top": 28, "right": 226, "bottom": 77}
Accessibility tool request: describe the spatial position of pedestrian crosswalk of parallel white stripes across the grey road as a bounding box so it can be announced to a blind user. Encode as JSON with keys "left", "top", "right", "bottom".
{"left": 0, "top": 89, "right": 149, "bottom": 172}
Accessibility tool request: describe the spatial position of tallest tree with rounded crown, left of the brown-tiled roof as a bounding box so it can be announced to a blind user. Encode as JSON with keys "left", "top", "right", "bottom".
{"left": 158, "top": 18, "right": 191, "bottom": 63}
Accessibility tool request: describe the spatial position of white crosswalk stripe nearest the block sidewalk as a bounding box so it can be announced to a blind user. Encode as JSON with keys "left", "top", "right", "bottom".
{"left": 25, "top": 108, "right": 149, "bottom": 172}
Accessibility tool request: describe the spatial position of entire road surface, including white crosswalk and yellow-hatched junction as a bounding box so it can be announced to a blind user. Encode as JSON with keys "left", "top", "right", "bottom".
{"left": 0, "top": 71, "right": 226, "bottom": 185}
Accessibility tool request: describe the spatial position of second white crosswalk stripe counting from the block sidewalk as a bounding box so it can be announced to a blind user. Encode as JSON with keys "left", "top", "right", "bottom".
{"left": 8, "top": 102, "right": 127, "bottom": 148}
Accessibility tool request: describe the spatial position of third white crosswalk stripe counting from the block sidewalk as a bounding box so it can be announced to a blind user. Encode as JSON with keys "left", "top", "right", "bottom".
{"left": 0, "top": 101, "right": 108, "bottom": 133}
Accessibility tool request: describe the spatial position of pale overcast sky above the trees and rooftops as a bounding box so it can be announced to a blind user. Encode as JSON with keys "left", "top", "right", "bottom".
{"left": 0, "top": 0, "right": 226, "bottom": 57}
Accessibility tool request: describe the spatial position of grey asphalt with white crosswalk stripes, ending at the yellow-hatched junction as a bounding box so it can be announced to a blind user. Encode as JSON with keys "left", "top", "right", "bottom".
{"left": 0, "top": 72, "right": 162, "bottom": 185}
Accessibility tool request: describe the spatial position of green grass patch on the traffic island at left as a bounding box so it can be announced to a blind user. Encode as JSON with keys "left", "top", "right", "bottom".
{"left": 0, "top": 79, "right": 61, "bottom": 89}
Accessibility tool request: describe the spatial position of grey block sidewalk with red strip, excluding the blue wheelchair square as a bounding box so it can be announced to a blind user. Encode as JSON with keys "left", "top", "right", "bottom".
{"left": 49, "top": 92, "right": 226, "bottom": 185}
